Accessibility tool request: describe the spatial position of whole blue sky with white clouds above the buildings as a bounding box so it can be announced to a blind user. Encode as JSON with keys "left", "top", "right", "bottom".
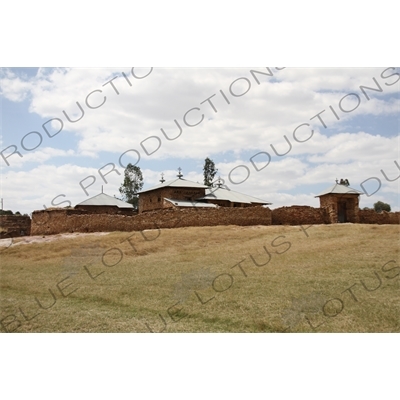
{"left": 0, "top": 67, "right": 400, "bottom": 213}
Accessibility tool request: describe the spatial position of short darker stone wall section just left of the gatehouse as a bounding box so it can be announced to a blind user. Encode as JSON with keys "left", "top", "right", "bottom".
{"left": 272, "top": 206, "right": 329, "bottom": 225}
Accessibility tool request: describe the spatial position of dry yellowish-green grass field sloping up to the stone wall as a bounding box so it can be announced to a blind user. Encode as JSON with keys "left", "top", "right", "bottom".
{"left": 0, "top": 224, "right": 400, "bottom": 332}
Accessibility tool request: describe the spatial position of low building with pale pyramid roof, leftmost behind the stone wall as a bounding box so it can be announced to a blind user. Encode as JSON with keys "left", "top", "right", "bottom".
{"left": 75, "top": 193, "right": 134, "bottom": 214}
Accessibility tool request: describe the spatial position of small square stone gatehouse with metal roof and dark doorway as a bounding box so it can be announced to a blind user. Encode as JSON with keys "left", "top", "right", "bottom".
{"left": 315, "top": 179, "right": 363, "bottom": 224}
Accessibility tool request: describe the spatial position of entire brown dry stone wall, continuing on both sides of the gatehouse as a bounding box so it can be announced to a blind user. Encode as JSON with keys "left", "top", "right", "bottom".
{"left": 28, "top": 206, "right": 400, "bottom": 235}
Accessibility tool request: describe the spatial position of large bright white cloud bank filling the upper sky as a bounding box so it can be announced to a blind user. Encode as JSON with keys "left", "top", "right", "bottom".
{"left": 4, "top": 68, "right": 399, "bottom": 162}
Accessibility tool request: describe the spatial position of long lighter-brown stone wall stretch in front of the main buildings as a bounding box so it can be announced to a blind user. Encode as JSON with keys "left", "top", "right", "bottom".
{"left": 31, "top": 207, "right": 271, "bottom": 235}
